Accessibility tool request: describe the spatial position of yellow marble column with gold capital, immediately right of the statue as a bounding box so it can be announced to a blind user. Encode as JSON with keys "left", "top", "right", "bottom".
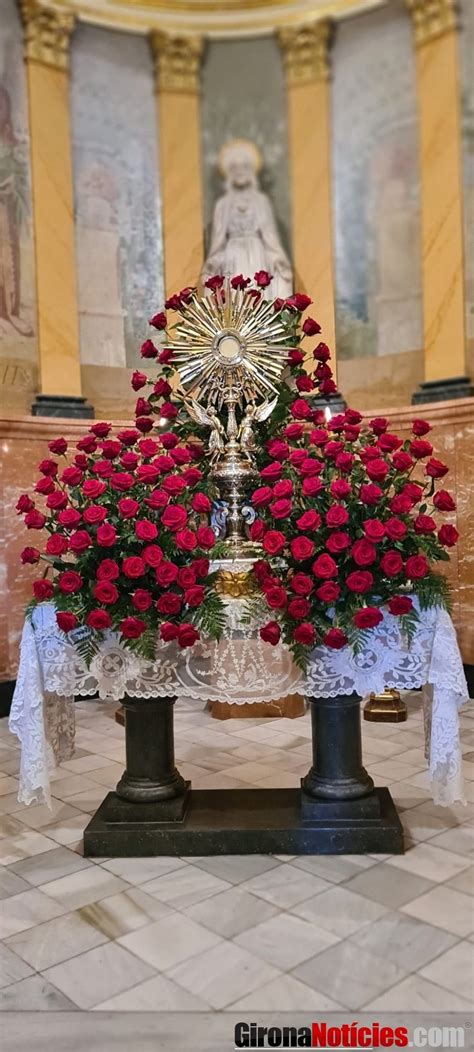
{"left": 279, "top": 19, "right": 336, "bottom": 397}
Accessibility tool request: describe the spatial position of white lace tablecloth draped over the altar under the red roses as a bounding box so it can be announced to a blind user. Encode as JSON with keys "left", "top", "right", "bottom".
{"left": 9, "top": 600, "right": 468, "bottom": 805}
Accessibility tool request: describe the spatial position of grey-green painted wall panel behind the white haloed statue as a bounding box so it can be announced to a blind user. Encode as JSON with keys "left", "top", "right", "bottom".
{"left": 201, "top": 38, "right": 290, "bottom": 267}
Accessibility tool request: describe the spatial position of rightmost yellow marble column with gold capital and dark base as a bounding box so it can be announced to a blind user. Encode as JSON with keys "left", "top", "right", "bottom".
{"left": 406, "top": 0, "right": 473, "bottom": 403}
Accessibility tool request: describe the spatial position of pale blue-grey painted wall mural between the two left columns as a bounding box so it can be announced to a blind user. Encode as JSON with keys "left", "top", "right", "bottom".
{"left": 70, "top": 26, "right": 164, "bottom": 367}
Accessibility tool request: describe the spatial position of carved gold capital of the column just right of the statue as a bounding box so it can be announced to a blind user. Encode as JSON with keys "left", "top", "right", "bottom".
{"left": 277, "top": 18, "right": 333, "bottom": 86}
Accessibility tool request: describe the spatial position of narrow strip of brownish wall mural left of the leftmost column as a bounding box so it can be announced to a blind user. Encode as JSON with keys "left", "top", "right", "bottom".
{"left": 0, "top": 0, "right": 37, "bottom": 401}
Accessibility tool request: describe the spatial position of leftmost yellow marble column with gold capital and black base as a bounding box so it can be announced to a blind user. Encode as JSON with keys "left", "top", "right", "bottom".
{"left": 20, "top": 0, "right": 94, "bottom": 418}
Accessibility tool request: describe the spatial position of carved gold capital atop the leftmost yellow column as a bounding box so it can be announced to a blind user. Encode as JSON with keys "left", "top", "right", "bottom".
{"left": 20, "top": 0, "right": 76, "bottom": 69}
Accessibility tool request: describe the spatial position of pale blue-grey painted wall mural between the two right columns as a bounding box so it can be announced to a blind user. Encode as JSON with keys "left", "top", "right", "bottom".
{"left": 332, "top": 4, "right": 423, "bottom": 360}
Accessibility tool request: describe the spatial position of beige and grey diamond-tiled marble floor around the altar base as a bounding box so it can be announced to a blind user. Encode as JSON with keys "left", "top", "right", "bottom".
{"left": 0, "top": 694, "right": 474, "bottom": 1013}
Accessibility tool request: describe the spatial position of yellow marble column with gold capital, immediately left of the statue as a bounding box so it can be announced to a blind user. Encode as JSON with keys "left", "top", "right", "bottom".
{"left": 150, "top": 31, "right": 204, "bottom": 296}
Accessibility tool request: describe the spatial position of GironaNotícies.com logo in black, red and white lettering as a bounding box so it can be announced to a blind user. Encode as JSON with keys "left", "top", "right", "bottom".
{"left": 234, "top": 1021, "right": 469, "bottom": 1052}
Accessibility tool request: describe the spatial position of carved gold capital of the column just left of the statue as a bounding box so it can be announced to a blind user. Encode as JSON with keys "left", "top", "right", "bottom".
{"left": 150, "top": 29, "right": 203, "bottom": 95}
